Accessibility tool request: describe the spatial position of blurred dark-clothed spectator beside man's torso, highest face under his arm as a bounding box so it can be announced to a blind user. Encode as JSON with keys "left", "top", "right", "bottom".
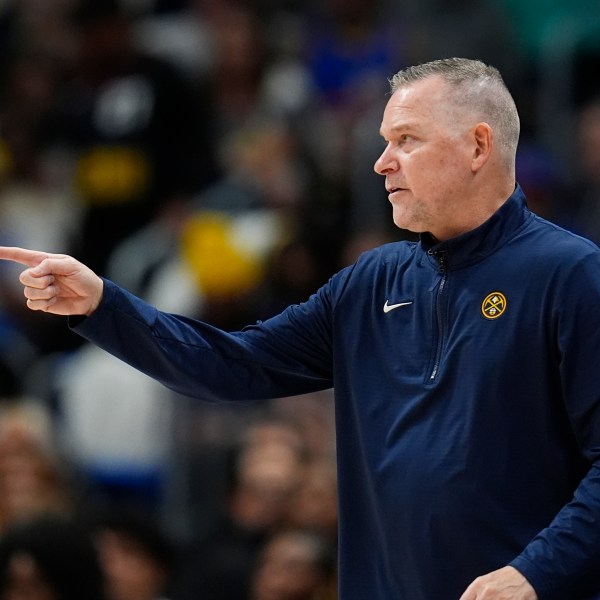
{"left": 172, "top": 421, "right": 304, "bottom": 600}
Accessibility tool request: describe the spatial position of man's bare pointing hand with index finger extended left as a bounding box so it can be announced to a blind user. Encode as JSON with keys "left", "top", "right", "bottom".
{"left": 0, "top": 246, "right": 104, "bottom": 316}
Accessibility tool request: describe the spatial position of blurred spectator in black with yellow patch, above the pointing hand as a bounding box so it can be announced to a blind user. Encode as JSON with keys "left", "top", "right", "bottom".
{"left": 58, "top": 0, "right": 214, "bottom": 272}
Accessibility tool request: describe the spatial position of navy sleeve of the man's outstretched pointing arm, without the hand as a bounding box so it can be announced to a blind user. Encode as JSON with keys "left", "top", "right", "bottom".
{"left": 69, "top": 280, "right": 333, "bottom": 401}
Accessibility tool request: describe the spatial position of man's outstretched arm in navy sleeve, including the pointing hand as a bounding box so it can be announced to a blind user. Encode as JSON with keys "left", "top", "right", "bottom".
{"left": 0, "top": 247, "right": 333, "bottom": 400}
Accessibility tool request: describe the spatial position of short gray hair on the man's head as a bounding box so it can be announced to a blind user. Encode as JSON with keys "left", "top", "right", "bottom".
{"left": 390, "top": 58, "right": 520, "bottom": 165}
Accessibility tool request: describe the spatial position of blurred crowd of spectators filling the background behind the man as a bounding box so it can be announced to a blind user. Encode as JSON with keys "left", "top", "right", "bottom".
{"left": 0, "top": 0, "right": 600, "bottom": 600}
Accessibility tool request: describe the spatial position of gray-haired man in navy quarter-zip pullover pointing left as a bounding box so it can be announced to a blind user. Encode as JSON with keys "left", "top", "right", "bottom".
{"left": 0, "top": 59, "right": 600, "bottom": 600}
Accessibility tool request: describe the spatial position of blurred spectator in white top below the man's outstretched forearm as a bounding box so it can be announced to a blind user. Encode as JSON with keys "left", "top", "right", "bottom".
{"left": 56, "top": 344, "right": 173, "bottom": 514}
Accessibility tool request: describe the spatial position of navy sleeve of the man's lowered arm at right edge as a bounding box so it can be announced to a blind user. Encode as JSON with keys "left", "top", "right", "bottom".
{"left": 511, "top": 253, "right": 600, "bottom": 600}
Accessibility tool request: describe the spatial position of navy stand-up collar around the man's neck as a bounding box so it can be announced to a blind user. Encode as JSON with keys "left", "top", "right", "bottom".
{"left": 420, "top": 184, "right": 533, "bottom": 269}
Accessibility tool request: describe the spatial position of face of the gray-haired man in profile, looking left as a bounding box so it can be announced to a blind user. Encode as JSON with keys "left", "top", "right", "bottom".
{"left": 375, "top": 77, "right": 473, "bottom": 240}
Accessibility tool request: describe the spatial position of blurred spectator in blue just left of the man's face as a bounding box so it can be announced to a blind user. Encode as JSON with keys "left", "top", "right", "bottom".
{"left": 298, "top": 0, "right": 410, "bottom": 258}
